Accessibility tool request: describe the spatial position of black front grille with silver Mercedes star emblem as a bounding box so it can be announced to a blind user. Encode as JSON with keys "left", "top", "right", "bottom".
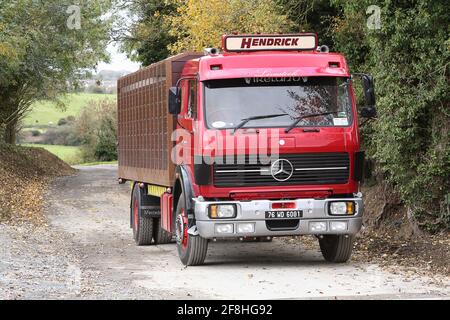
{"left": 214, "top": 152, "right": 350, "bottom": 187}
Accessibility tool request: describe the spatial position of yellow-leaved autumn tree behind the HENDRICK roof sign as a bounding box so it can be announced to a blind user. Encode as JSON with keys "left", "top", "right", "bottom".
{"left": 168, "top": 0, "right": 291, "bottom": 53}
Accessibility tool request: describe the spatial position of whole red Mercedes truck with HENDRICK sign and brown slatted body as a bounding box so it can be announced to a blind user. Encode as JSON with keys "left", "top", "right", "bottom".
{"left": 118, "top": 33, "right": 376, "bottom": 265}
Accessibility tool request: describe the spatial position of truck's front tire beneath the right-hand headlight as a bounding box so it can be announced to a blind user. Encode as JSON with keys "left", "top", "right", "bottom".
{"left": 319, "top": 235, "right": 354, "bottom": 263}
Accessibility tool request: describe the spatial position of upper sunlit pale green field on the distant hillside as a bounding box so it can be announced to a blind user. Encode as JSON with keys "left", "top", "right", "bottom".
{"left": 24, "top": 93, "right": 116, "bottom": 127}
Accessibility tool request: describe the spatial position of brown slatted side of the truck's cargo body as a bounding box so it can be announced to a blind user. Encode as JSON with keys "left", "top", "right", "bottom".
{"left": 117, "top": 53, "right": 200, "bottom": 186}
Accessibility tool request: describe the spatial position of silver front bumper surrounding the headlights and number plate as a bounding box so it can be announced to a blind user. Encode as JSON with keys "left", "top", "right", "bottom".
{"left": 194, "top": 198, "right": 364, "bottom": 239}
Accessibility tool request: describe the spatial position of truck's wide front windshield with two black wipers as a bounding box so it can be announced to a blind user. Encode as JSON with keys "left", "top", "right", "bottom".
{"left": 204, "top": 77, "right": 352, "bottom": 129}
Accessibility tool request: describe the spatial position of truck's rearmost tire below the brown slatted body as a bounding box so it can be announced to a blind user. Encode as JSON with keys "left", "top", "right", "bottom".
{"left": 131, "top": 183, "right": 153, "bottom": 246}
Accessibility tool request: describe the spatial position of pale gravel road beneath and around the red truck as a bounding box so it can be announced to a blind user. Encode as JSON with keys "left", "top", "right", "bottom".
{"left": 0, "top": 165, "right": 450, "bottom": 299}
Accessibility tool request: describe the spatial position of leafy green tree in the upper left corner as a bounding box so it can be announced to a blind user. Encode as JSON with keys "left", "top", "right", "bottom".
{"left": 0, "top": 0, "right": 113, "bottom": 143}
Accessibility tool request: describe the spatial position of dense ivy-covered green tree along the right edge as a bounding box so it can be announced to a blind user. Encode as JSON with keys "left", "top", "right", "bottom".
{"left": 333, "top": 0, "right": 450, "bottom": 231}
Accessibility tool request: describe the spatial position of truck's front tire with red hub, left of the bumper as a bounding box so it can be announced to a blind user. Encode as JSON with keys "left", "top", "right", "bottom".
{"left": 174, "top": 193, "right": 208, "bottom": 266}
